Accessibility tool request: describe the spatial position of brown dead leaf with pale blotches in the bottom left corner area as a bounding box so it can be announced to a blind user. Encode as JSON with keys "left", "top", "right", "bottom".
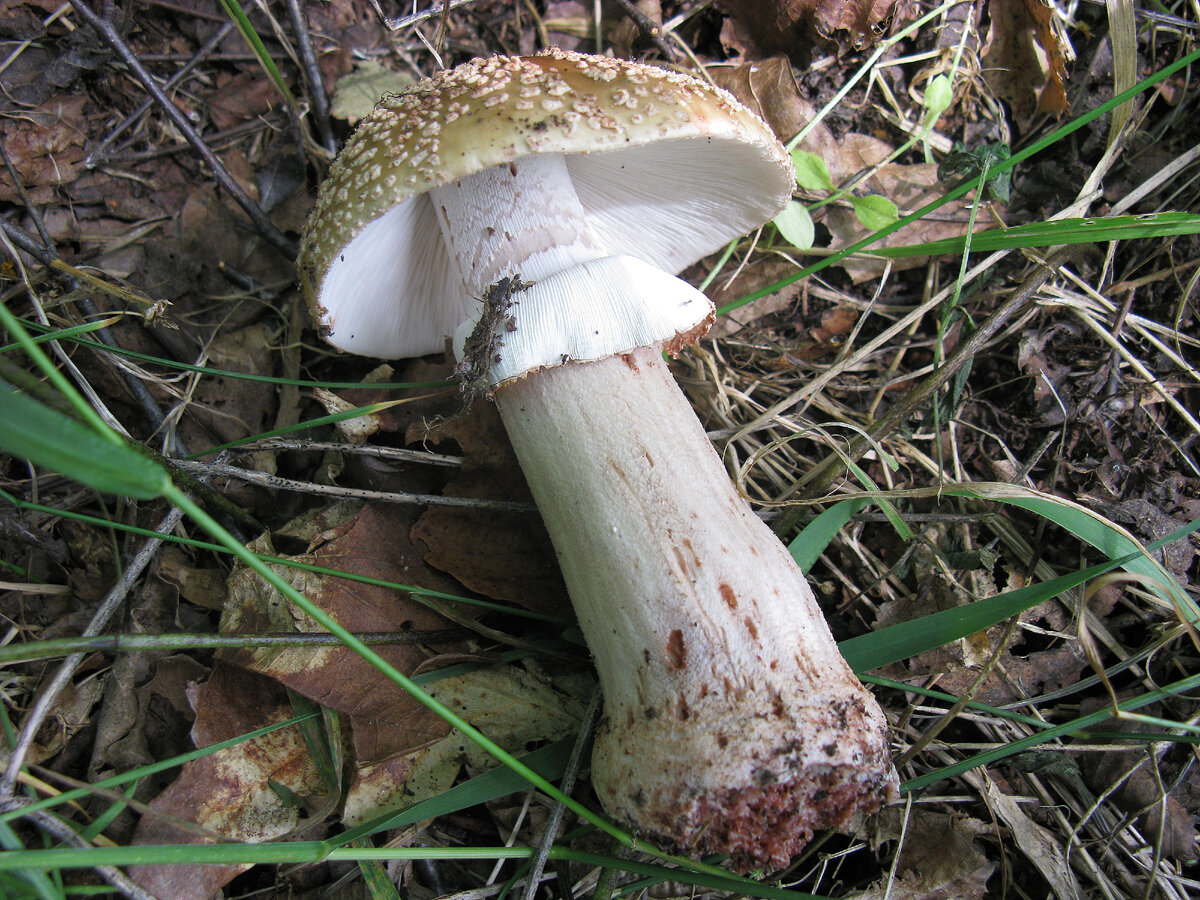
{"left": 130, "top": 666, "right": 322, "bottom": 900}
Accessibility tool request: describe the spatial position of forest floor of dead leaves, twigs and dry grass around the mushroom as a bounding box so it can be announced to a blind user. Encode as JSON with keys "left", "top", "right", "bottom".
{"left": 0, "top": 0, "right": 1200, "bottom": 900}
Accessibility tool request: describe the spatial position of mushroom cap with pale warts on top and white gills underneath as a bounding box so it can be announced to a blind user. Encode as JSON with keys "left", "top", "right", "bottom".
{"left": 299, "top": 49, "right": 794, "bottom": 359}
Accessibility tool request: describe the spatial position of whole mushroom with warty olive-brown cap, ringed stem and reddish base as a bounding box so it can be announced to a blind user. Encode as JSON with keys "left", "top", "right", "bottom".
{"left": 300, "top": 50, "right": 898, "bottom": 869}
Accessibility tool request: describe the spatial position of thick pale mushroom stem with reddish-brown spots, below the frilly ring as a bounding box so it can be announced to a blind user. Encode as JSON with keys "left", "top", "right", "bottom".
{"left": 496, "top": 348, "right": 896, "bottom": 868}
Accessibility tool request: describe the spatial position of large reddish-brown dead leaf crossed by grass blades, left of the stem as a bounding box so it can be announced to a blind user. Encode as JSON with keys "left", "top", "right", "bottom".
{"left": 221, "top": 503, "right": 460, "bottom": 762}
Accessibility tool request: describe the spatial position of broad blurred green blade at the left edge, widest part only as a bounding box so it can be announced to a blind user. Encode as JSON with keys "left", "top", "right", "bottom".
{"left": 0, "top": 382, "right": 170, "bottom": 500}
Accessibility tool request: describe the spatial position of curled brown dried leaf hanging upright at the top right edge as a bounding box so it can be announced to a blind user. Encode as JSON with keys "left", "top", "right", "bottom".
{"left": 983, "top": 0, "right": 1068, "bottom": 130}
